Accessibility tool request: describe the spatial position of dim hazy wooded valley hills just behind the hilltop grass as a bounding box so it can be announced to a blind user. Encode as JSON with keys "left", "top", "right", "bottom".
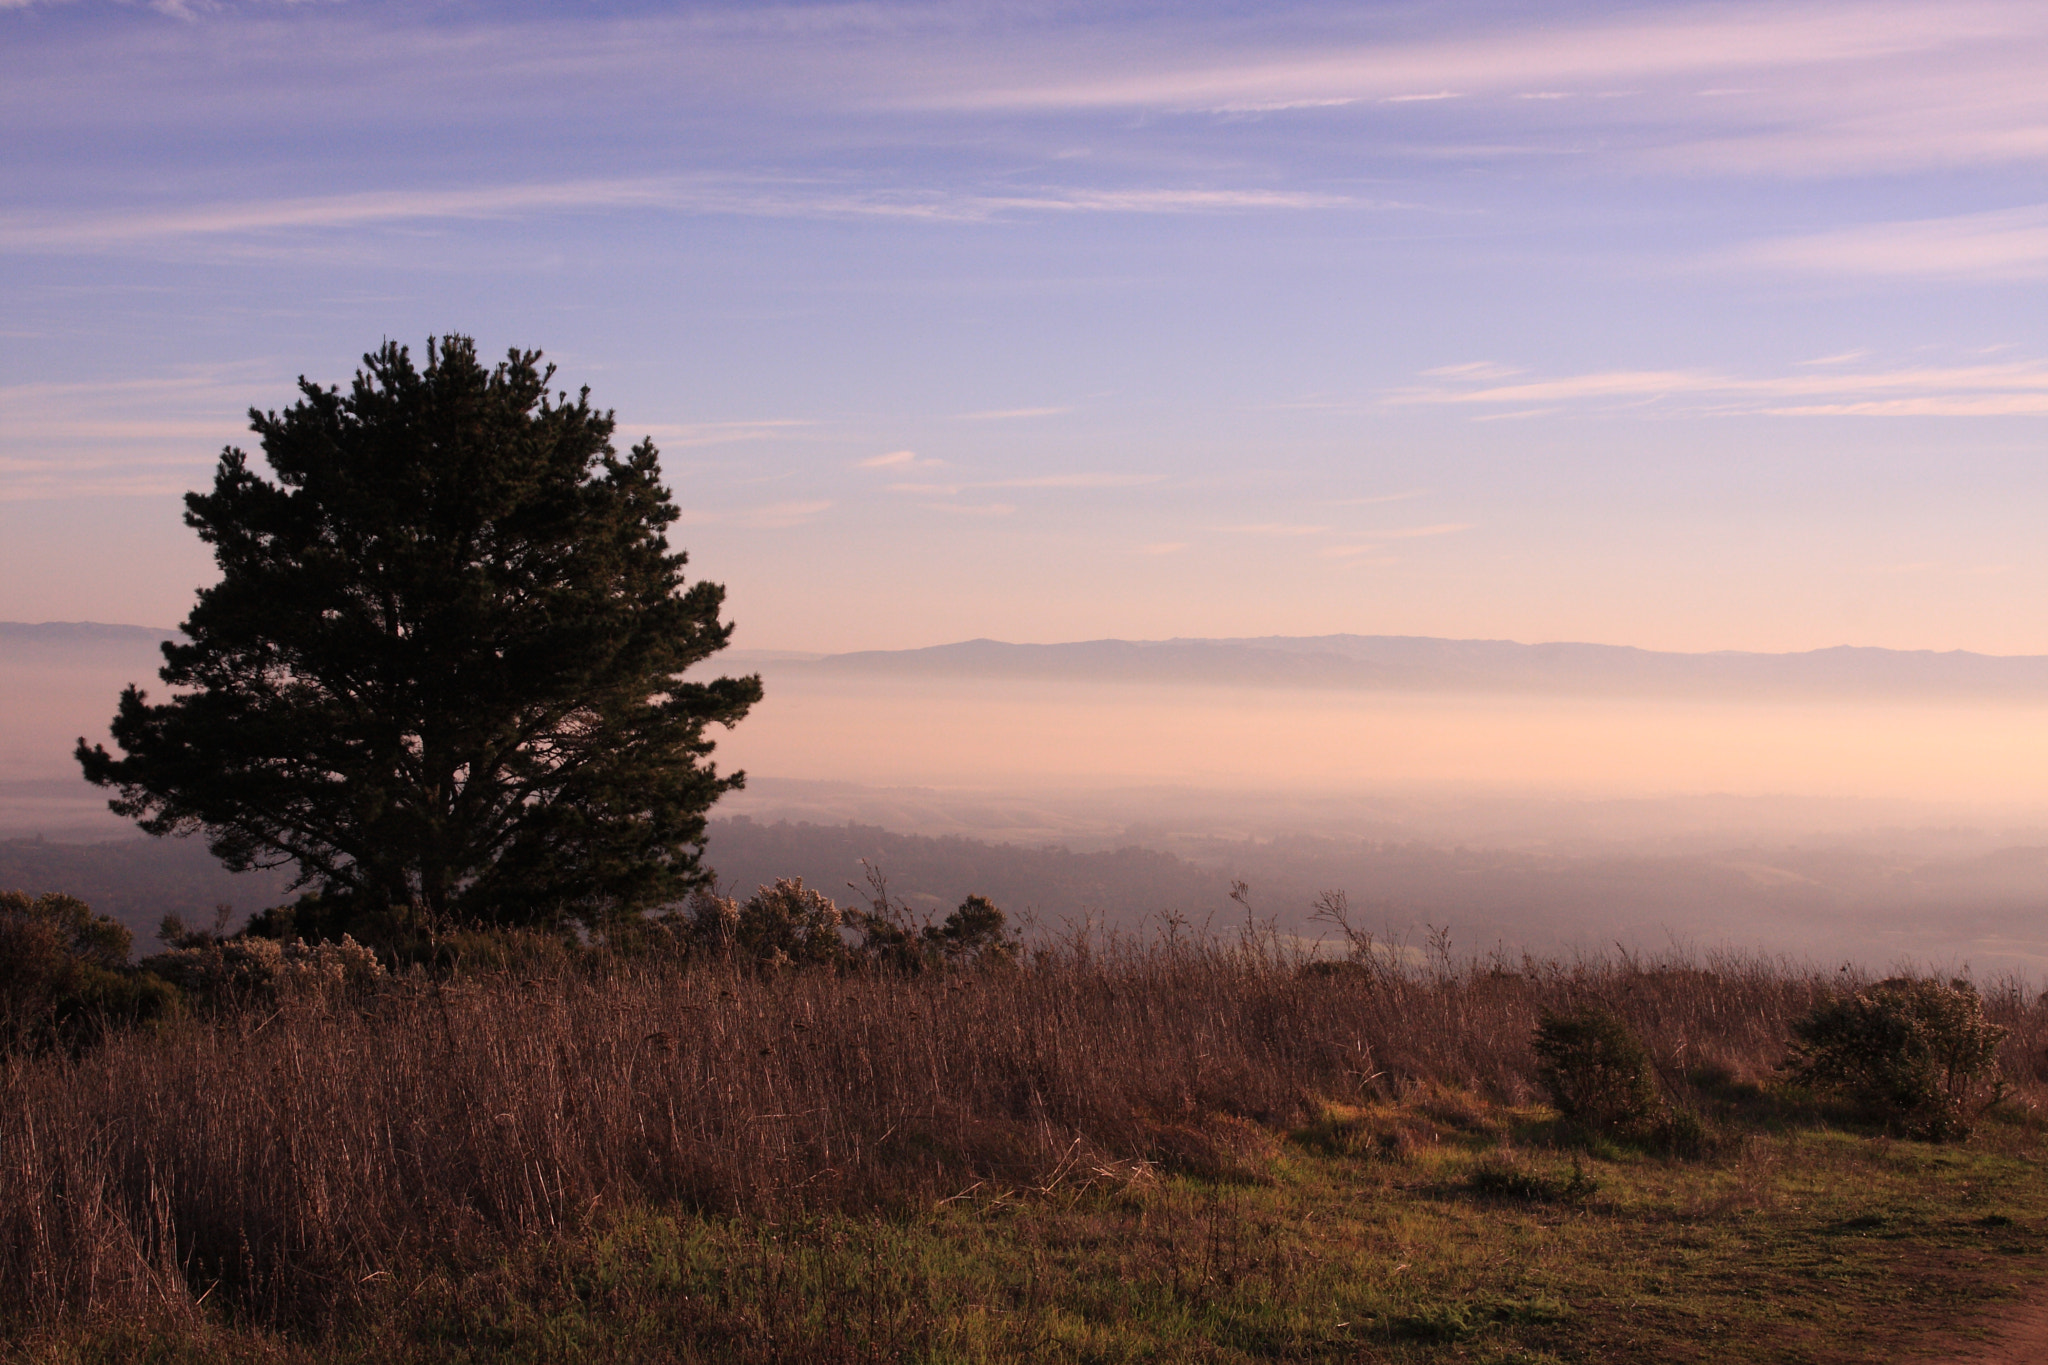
{"left": 12, "top": 817, "right": 2048, "bottom": 974}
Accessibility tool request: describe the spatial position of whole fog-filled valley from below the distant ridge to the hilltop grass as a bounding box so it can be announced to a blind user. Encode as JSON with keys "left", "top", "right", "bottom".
{"left": 12, "top": 632, "right": 2048, "bottom": 976}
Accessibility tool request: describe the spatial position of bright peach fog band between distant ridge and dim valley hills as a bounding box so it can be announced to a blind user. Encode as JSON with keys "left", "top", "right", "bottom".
{"left": 721, "top": 667, "right": 2048, "bottom": 806}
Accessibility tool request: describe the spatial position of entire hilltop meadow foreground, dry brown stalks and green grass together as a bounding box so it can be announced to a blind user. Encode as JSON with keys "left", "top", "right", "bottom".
{"left": 0, "top": 884, "right": 2048, "bottom": 1363}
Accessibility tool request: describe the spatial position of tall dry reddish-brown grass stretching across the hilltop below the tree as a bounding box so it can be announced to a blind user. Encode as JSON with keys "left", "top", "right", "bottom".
{"left": 0, "top": 916, "right": 2044, "bottom": 1324}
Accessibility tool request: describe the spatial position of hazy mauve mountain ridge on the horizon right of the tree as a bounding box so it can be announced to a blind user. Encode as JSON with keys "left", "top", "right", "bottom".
{"left": 802, "top": 634, "right": 2048, "bottom": 700}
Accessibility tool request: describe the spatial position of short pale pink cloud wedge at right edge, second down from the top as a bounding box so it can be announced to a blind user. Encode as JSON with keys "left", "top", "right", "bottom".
{"left": 1729, "top": 205, "right": 2048, "bottom": 280}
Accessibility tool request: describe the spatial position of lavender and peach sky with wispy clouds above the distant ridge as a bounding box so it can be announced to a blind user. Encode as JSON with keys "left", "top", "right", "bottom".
{"left": 0, "top": 0, "right": 2048, "bottom": 653}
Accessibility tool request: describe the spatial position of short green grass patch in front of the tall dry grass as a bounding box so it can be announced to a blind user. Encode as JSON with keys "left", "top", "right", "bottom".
{"left": 16, "top": 1095, "right": 2048, "bottom": 1365}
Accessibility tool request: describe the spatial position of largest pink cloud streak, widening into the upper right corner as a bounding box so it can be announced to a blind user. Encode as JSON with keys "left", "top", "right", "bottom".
{"left": 899, "top": 0, "right": 2048, "bottom": 174}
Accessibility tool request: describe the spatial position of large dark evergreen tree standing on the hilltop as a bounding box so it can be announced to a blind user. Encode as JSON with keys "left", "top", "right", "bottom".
{"left": 78, "top": 336, "right": 762, "bottom": 941}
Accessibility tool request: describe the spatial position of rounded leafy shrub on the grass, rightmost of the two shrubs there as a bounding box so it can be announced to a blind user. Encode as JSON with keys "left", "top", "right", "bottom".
{"left": 1788, "top": 976, "right": 2007, "bottom": 1142}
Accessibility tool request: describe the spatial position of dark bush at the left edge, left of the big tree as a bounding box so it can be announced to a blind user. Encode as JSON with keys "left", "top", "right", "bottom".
{"left": 0, "top": 890, "right": 178, "bottom": 1050}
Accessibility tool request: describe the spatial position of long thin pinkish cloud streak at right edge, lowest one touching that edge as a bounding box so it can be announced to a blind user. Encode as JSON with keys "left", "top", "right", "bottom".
{"left": 1386, "top": 360, "right": 2048, "bottom": 417}
